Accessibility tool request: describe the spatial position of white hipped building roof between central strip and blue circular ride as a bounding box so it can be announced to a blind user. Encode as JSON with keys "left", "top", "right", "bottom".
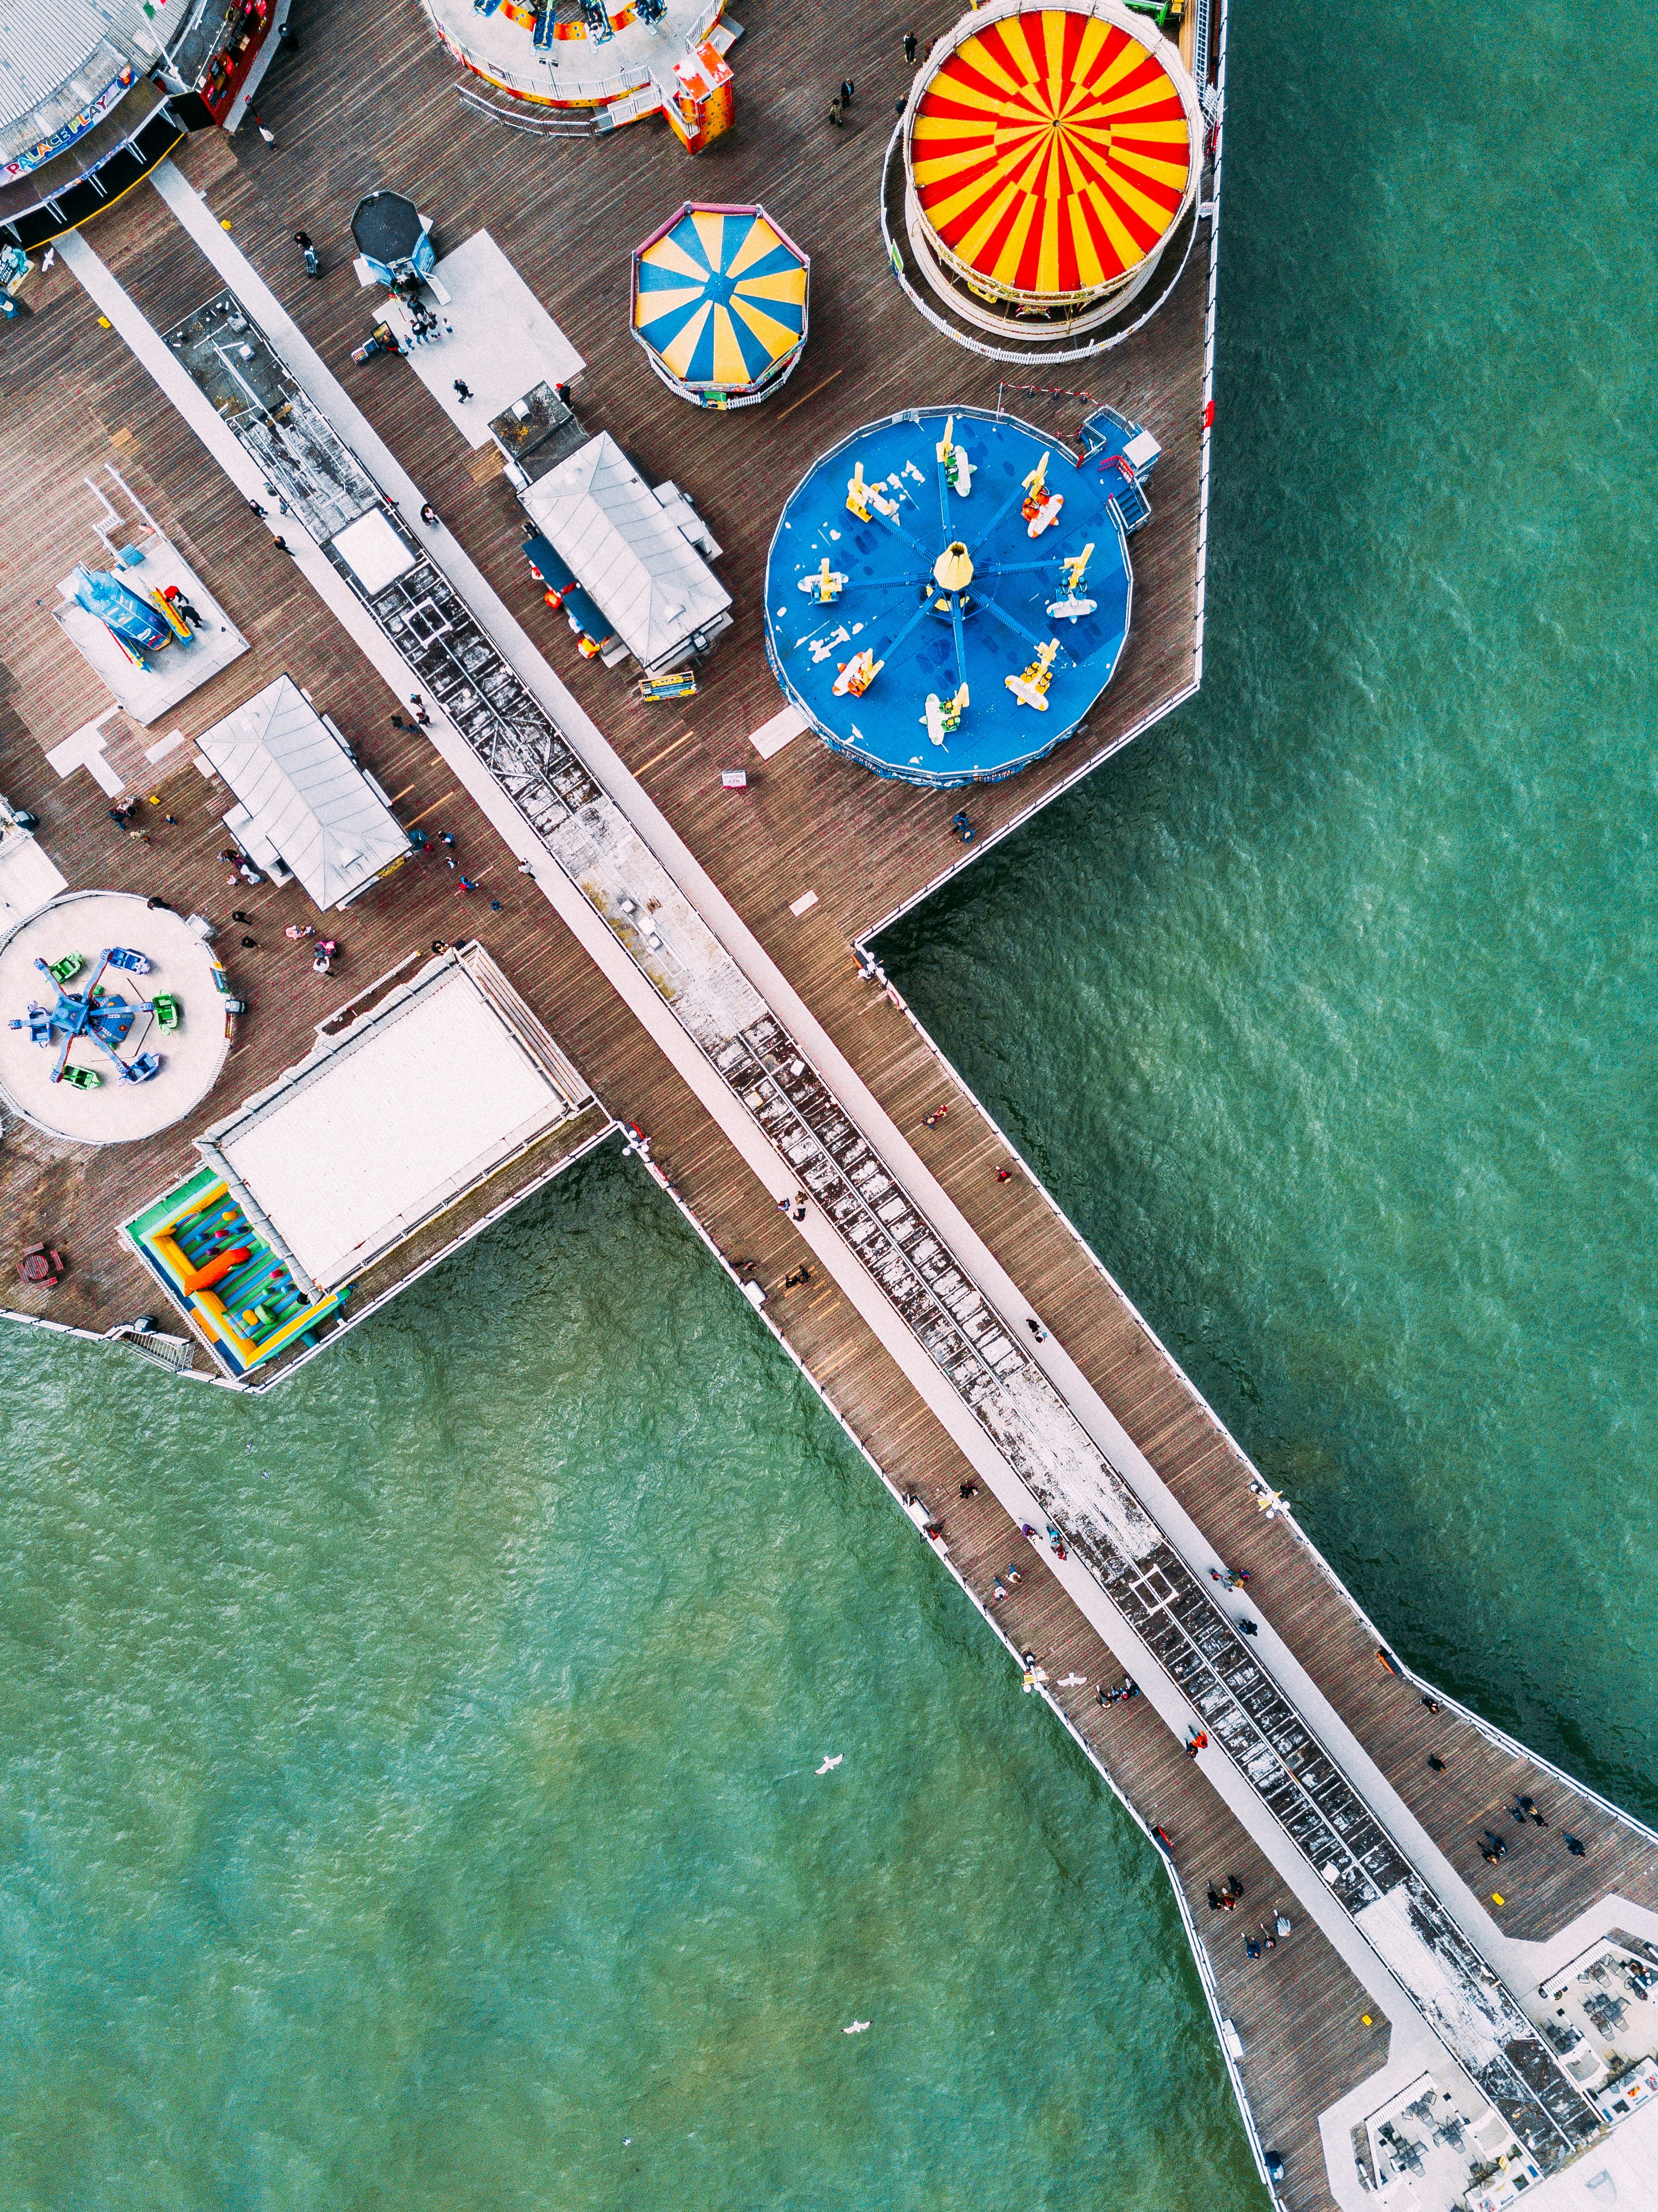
{"left": 520, "top": 431, "right": 730, "bottom": 668}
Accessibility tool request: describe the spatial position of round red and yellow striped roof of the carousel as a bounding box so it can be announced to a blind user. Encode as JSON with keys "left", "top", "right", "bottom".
{"left": 910, "top": 7, "right": 1193, "bottom": 294}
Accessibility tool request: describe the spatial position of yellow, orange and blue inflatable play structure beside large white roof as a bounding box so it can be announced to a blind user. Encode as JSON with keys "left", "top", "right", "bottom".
{"left": 124, "top": 1168, "right": 347, "bottom": 1380}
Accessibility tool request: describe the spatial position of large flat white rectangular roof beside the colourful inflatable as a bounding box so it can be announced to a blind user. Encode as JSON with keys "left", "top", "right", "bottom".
{"left": 202, "top": 951, "right": 587, "bottom": 1289}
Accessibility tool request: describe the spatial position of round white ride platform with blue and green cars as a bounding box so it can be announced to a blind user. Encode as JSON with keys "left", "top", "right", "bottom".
{"left": 0, "top": 892, "right": 230, "bottom": 1144}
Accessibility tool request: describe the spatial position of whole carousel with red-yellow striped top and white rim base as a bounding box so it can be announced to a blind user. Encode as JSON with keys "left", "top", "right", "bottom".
{"left": 894, "top": 0, "right": 1204, "bottom": 350}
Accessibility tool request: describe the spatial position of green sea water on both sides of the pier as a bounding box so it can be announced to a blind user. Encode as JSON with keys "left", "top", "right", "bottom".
{"left": 0, "top": 0, "right": 1658, "bottom": 2212}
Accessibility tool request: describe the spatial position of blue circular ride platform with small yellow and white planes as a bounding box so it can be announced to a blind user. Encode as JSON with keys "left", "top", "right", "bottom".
{"left": 766, "top": 407, "right": 1133, "bottom": 785}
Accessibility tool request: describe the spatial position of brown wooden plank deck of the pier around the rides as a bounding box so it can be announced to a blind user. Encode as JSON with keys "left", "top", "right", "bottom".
{"left": 0, "top": 0, "right": 1658, "bottom": 2212}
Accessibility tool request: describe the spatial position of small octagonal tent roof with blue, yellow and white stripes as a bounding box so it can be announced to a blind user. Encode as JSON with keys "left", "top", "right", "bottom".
{"left": 633, "top": 206, "right": 808, "bottom": 392}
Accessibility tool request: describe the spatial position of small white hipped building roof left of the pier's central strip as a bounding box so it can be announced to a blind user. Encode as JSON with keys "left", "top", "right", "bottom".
{"left": 197, "top": 677, "right": 410, "bottom": 909}
